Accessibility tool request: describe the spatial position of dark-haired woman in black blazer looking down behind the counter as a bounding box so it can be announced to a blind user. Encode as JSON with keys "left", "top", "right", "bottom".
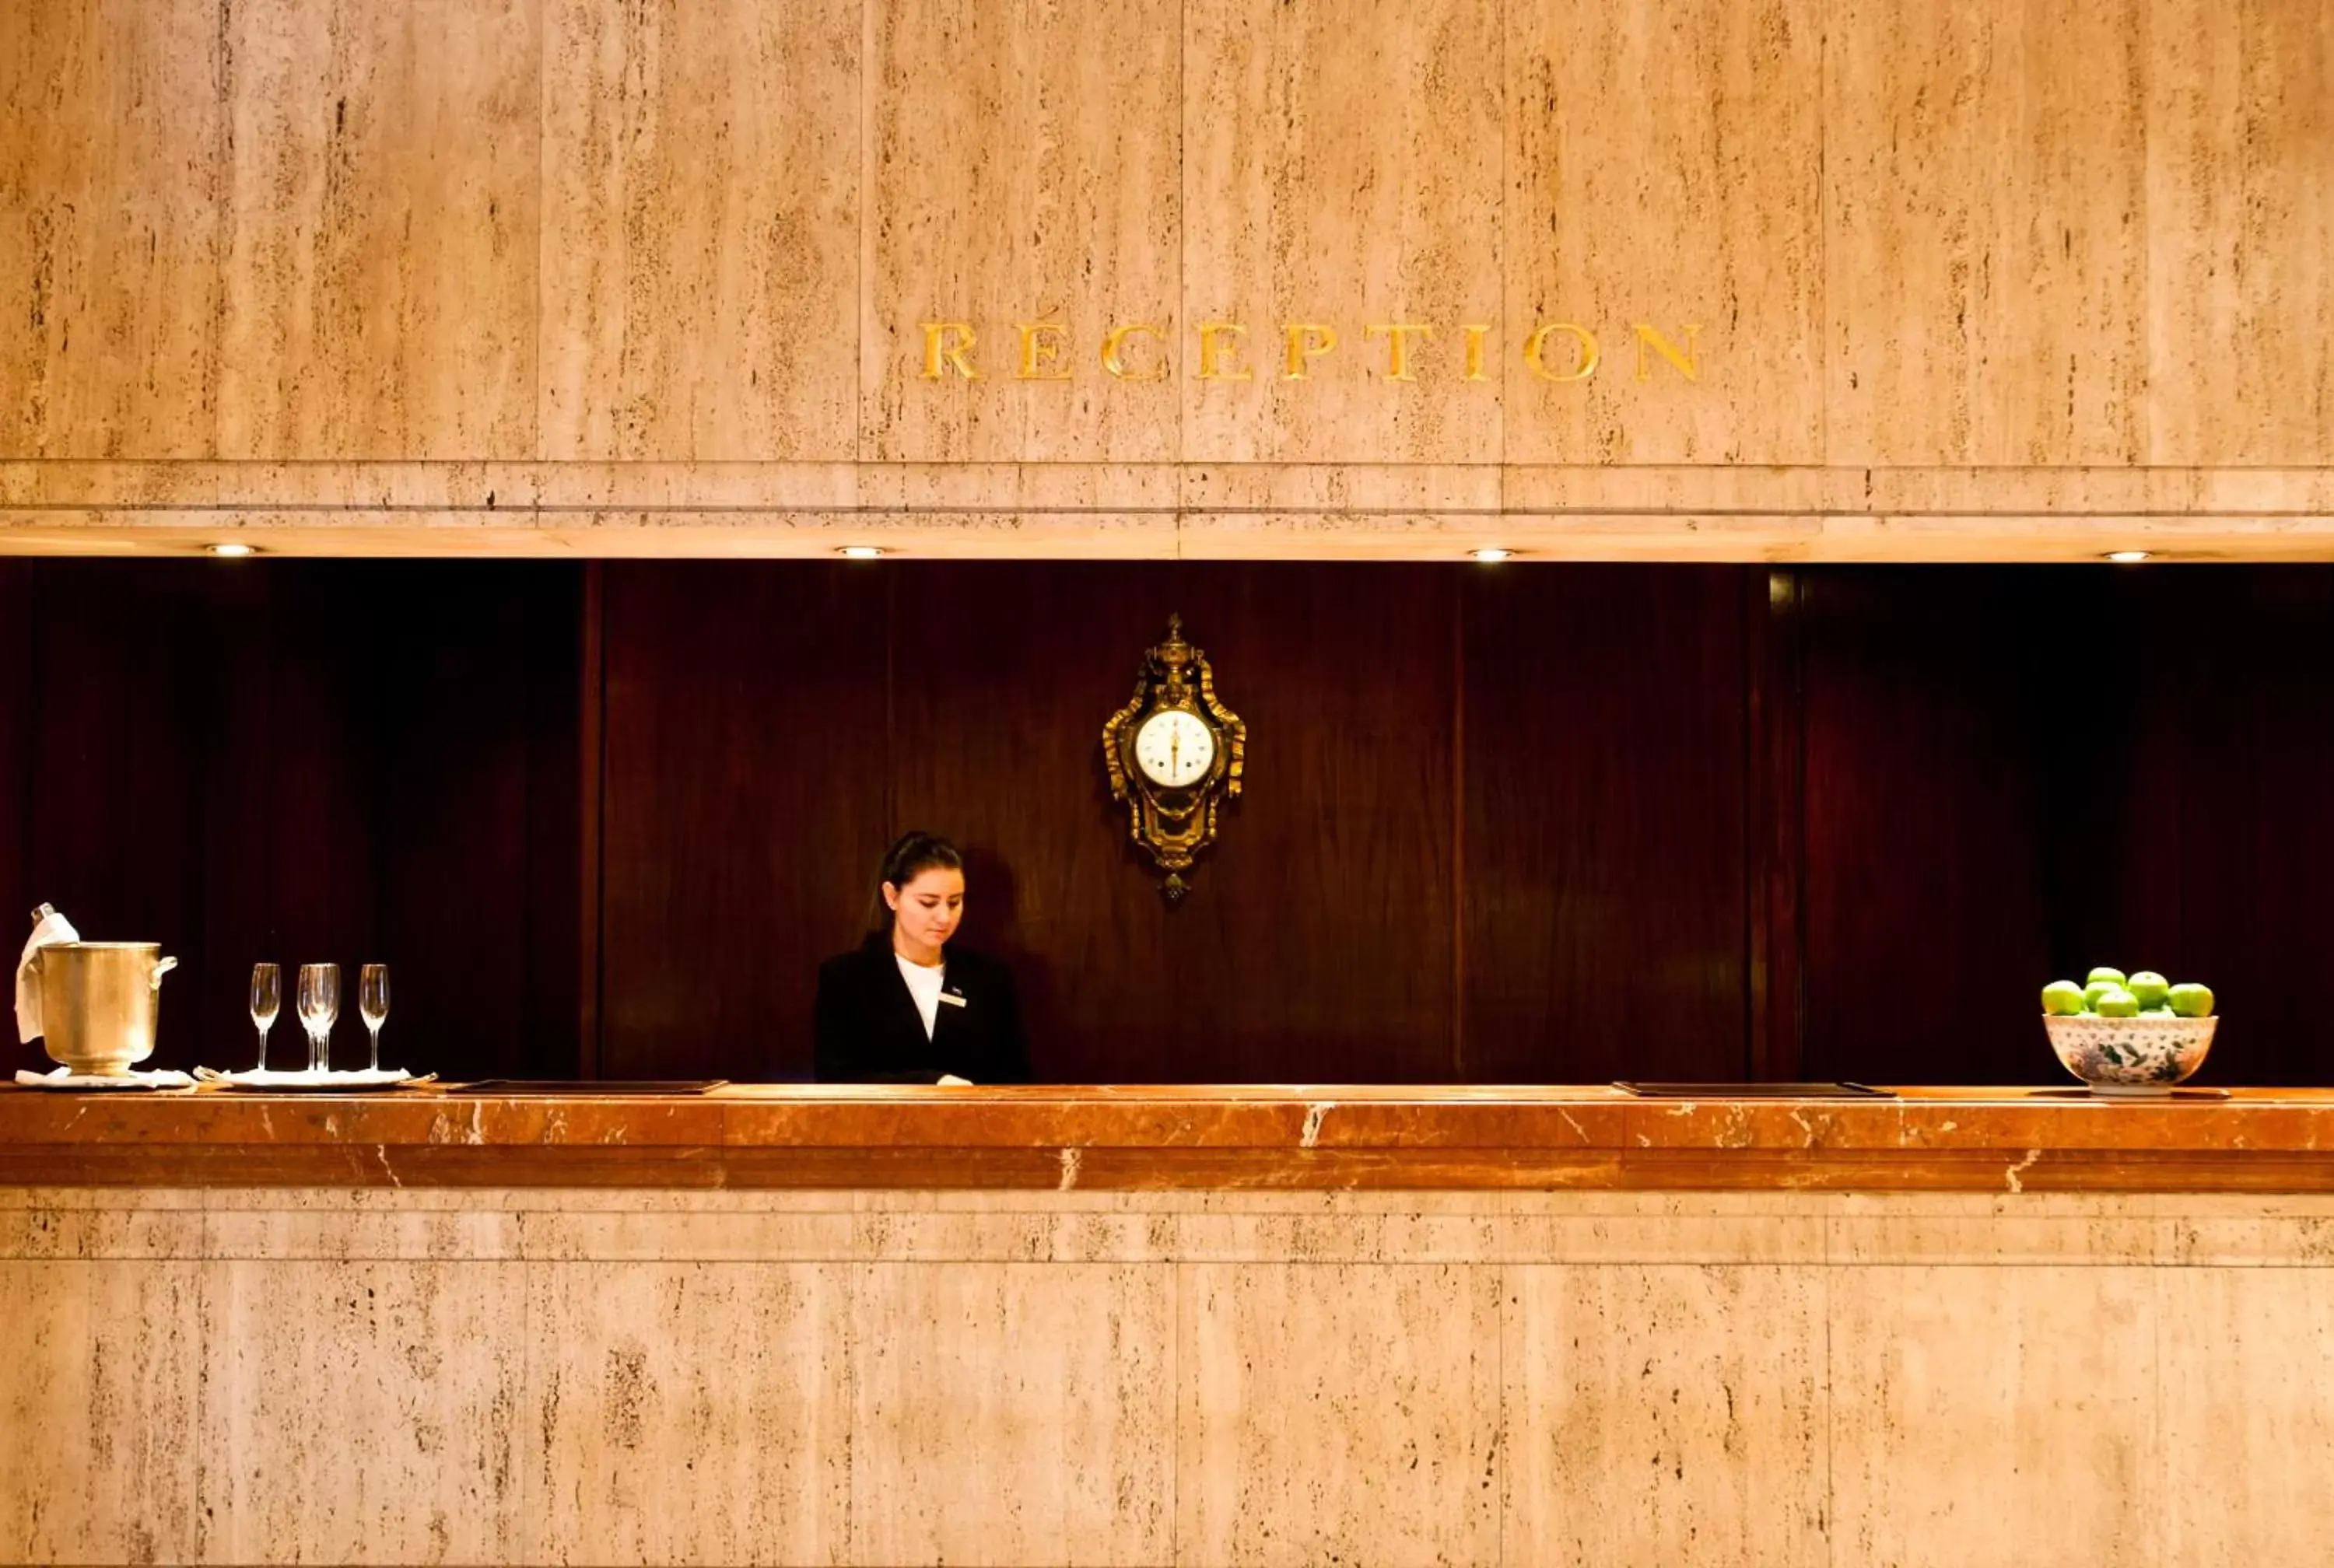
{"left": 812, "top": 833, "right": 1029, "bottom": 1083}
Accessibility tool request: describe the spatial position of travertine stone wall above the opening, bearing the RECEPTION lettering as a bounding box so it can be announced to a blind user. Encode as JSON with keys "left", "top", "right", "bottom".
{"left": 0, "top": 0, "right": 2334, "bottom": 558}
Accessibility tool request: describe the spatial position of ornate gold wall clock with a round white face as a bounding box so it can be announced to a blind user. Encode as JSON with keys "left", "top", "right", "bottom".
{"left": 1102, "top": 616, "right": 1249, "bottom": 903}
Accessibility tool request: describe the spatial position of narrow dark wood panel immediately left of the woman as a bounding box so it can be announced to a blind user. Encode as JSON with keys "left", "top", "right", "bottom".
{"left": 600, "top": 562, "right": 887, "bottom": 1078}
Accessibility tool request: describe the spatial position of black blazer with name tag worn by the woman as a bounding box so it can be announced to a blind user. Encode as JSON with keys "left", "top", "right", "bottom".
{"left": 812, "top": 936, "right": 1029, "bottom": 1083}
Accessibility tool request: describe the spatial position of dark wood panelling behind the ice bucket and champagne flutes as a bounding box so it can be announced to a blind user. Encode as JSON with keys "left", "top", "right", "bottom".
{"left": 0, "top": 562, "right": 579, "bottom": 1073}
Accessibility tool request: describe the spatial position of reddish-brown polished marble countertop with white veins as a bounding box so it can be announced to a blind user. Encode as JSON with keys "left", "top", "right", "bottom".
{"left": 0, "top": 1085, "right": 2334, "bottom": 1192}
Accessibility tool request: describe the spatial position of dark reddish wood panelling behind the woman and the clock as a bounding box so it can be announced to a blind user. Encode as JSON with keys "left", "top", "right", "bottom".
{"left": 605, "top": 562, "right": 1452, "bottom": 1080}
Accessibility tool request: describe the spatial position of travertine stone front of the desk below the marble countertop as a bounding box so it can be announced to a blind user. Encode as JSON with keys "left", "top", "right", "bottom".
{"left": 0, "top": 1190, "right": 2334, "bottom": 1568}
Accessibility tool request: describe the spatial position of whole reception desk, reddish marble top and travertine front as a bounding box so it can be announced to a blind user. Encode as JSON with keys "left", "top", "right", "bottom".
{"left": 0, "top": 1085, "right": 2334, "bottom": 1568}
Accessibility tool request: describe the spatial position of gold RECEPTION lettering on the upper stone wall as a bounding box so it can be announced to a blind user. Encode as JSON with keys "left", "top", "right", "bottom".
{"left": 901, "top": 320, "right": 1701, "bottom": 385}
